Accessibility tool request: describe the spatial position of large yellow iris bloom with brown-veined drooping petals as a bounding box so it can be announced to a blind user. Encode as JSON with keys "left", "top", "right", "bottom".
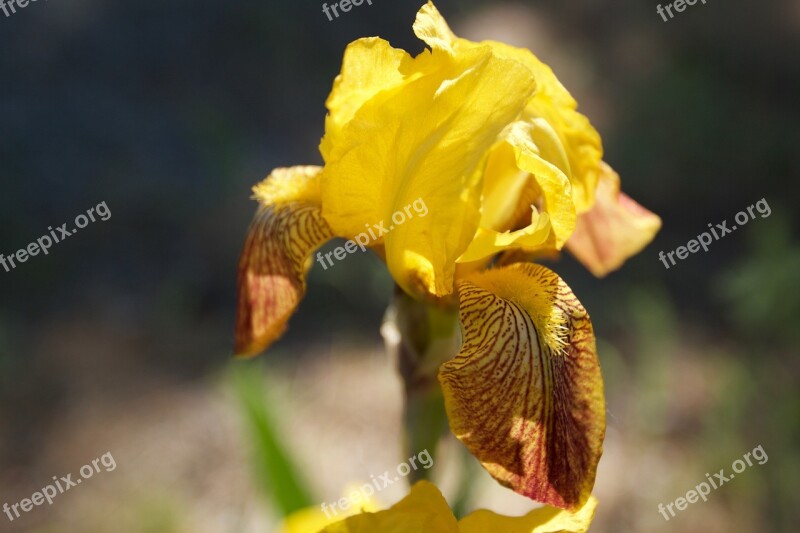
{"left": 236, "top": 2, "right": 660, "bottom": 510}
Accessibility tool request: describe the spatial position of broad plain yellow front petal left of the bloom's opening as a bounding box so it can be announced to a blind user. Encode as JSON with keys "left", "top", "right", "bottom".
{"left": 322, "top": 42, "right": 535, "bottom": 296}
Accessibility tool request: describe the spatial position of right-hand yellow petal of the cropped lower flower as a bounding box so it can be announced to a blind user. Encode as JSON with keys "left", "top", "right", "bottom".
{"left": 458, "top": 496, "right": 597, "bottom": 533}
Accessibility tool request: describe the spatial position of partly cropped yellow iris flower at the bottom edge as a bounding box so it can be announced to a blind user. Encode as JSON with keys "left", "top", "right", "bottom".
{"left": 281, "top": 481, "right": 597, "bottom": 533}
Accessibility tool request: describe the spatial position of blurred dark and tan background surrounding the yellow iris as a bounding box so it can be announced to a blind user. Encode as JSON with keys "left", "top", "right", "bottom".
{"left": 0, "top": 0, "right": 800, "bottom": 532}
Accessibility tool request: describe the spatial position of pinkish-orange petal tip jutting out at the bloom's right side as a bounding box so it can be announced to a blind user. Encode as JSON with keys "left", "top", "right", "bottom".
{"left": 567, "top": 163, "right": 661, "bottom": 277}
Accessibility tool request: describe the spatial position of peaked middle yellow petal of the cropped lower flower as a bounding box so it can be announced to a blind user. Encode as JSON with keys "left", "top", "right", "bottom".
{"left": 323, "top": 481, "right": 458, "bottom": 533}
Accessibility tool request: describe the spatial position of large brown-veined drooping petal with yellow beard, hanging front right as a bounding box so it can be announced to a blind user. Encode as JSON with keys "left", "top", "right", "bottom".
{"left": 439, "top": 264, "right": 605, "bottom": 509}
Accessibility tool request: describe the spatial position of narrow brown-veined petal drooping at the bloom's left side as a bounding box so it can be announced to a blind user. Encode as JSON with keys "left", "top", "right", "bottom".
{"left": 236, "top": 166, "right": 333, "bottom": 356}
